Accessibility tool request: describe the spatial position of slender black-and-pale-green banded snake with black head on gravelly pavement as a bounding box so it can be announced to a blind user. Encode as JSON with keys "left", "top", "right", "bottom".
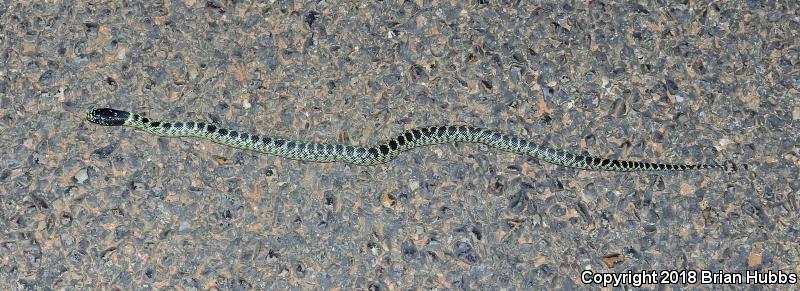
{"left": 86, "top": 108, "right": 735, "bottom": 172}
